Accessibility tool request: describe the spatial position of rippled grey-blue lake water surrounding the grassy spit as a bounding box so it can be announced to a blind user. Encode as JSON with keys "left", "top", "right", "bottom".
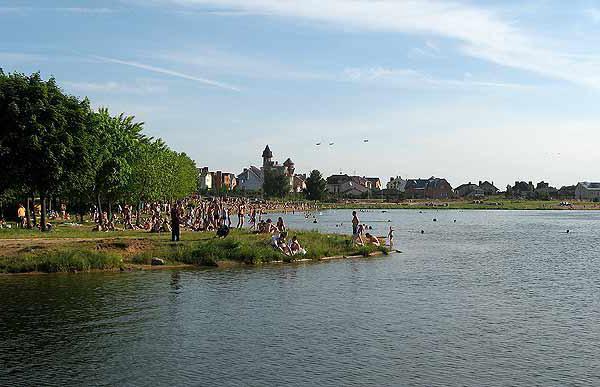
{"left": 0, "top": 210, "right": 600, "bottom": 386}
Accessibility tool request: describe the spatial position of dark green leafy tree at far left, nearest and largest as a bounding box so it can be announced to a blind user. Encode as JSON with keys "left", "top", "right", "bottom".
{"left": 0, "top": 71, "right": 90, "bottom": 230}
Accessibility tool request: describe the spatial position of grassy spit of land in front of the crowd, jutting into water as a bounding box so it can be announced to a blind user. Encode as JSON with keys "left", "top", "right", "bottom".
{"left": 0, "top": 225, "right": 386, "bottom": 273}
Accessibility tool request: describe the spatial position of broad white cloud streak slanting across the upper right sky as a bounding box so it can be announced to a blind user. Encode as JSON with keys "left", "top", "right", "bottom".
{"left": 158, "top": 0, "right": 600, "bottom": 88}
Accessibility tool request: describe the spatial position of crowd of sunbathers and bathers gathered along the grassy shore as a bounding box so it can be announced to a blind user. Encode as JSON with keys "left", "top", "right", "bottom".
{"left": 8, "top": 197, "right": 394, "bottom": 256}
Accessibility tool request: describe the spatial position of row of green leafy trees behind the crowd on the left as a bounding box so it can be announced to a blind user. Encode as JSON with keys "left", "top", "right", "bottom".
{"left": 0, "top": 69, "right": 198, "bottom": 230}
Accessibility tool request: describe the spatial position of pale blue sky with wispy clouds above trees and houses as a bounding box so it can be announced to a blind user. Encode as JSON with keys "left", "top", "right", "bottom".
{"left": 0, "top": 0, "right": 600, "bottom": 188}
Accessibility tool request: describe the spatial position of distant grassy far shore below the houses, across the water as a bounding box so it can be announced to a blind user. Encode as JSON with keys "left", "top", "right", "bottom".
{"left": 323, "top": 195, "right": 600, "bottom": 210}
